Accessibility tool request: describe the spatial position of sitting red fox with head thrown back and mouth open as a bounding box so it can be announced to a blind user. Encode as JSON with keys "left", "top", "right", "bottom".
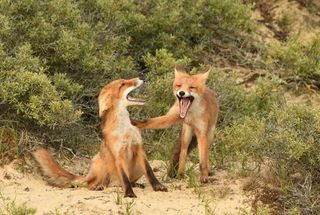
{"left": 33, "top": 78, "right": 167, "bottom": 197}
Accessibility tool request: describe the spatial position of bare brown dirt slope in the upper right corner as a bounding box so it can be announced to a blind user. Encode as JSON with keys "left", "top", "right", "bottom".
{"left": 252, "top": 0, "right": 320, "bottom": 42}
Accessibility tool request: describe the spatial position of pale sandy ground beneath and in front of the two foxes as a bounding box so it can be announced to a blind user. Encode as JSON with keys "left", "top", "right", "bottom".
{"left": 0, "top": 161, "right": 254, "bottom": 215}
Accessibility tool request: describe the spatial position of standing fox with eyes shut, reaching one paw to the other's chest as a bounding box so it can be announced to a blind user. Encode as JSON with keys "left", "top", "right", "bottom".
{"left": 132, "top": 66, "right": 219, "bottom": 183}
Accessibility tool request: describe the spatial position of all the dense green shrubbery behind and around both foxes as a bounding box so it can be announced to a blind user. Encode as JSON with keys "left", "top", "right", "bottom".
{"left": 0, "top": 0, "right": 320, "bottom": 214}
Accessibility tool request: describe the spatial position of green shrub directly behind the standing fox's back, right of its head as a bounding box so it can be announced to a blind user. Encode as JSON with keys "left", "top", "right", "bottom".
{"left": 207, "top": 70, "right": 284, "bottom": 127}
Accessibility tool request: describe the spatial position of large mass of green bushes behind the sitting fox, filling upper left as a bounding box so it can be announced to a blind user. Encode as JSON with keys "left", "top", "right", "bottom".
{"left": 0, "top": 0, "right": 254, "bottom": 142}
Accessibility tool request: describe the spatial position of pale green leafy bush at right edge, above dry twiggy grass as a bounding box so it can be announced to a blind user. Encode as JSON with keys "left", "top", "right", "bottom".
{"left": 218, "top": 106, "right": 320, "bottom": 169}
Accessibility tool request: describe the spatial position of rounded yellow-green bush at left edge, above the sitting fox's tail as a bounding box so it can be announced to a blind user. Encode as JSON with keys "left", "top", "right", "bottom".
{"left": 0, "top": 45, "right": 81, "bottom": 128}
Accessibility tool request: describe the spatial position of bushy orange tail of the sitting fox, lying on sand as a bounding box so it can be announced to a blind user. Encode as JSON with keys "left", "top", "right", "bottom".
{"left": 33, "top": 148, "right": 83, "bottom": 187}
